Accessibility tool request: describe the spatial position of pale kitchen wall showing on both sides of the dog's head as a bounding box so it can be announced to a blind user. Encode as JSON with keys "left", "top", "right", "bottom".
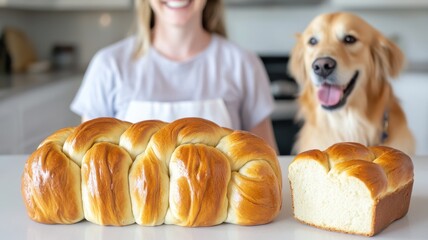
{"left": 227, "top": 6, "right": 428, "bottom": 67}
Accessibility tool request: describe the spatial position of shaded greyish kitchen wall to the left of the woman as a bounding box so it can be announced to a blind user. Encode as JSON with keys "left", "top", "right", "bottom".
{"left": 0, "top": 9, "right": 133, "bottom": 67}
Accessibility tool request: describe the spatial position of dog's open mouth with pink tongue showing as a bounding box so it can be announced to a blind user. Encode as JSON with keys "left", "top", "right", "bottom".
{"left": 317, "top": 71, "right": 359, "bottom": 110}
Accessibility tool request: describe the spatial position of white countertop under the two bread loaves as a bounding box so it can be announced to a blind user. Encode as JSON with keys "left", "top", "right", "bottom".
{"left": 0, "top": 155, "right": 428, "bottom": 240}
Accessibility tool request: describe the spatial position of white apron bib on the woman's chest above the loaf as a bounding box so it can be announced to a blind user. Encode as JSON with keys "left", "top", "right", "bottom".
{"left": 124, "top": 98, "right": 232, "bottom": 128}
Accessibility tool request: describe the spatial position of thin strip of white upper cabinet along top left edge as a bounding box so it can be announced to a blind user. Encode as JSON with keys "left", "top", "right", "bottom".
{"left": 0, "top": 0, "right": 133, "bottom": 10}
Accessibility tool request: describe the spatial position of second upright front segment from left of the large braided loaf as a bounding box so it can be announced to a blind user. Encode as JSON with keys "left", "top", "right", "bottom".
{"left": 82, "top": 142, "right": 134, "bottom": 226}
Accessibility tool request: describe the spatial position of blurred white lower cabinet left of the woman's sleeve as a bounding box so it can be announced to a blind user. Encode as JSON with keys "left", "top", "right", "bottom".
{"left": 0, "top": 76, "right": 82, "bottom": 154}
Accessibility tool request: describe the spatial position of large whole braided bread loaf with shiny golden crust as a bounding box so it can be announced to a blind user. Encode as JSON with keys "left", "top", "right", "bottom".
{"left": 21, "top": 118, "right": 282, "bottom": 226}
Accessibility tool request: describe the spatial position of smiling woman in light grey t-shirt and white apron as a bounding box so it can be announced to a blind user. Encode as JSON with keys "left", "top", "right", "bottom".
{"left": 71, "top": 0, "right": 277, "bottom": 152}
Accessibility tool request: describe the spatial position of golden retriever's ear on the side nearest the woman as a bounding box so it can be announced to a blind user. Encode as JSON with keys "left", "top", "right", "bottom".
{"left": 288, "top": 33, "right": 306, "bottom": 85}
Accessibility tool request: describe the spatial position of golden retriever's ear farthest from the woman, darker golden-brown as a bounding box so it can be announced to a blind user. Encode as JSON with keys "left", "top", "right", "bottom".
{"left": 372, "top": 33, "right": 404, "bottom": 78}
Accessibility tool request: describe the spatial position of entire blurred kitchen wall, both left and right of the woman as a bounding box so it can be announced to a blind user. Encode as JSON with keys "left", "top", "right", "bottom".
{"left": 0, "top": 6, "right": 428, "bottom": 66}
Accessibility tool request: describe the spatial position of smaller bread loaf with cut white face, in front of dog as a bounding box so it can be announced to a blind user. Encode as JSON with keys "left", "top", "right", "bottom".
{"left": 288, "top": 142, "right": 413, "bottom": 236}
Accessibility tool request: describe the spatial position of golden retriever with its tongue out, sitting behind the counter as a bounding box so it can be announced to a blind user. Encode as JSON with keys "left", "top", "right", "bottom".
{"left": 288, "top": 12, "right": 415, "bottom": 155}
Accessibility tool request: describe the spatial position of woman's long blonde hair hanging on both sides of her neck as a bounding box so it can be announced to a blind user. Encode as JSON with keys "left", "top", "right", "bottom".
{"left": 134, "top": 0, "right": 226, "bottom": 58}
